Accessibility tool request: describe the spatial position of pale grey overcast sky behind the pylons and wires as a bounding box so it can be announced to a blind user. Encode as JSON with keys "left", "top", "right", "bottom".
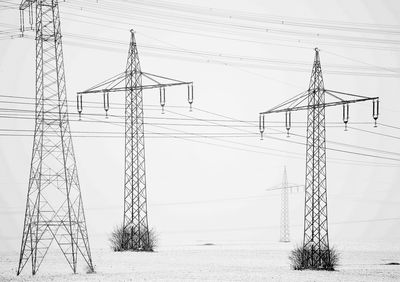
{"left": 0, "top": 0, "right": 400, "bottom": 251}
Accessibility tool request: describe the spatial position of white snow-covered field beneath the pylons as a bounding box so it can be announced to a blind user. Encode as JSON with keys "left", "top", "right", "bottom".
{"left": 0, "top": 243, "right": 400, "bottom": 282}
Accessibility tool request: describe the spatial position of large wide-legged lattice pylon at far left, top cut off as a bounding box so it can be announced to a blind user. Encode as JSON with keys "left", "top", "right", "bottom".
{"left": 17, "top": 0, "right": 93, "bottom": 275}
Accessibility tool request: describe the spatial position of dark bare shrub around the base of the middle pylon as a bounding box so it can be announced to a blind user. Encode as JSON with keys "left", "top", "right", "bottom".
{"left": 109, "top": 225, "right": 158, "bottom": 252}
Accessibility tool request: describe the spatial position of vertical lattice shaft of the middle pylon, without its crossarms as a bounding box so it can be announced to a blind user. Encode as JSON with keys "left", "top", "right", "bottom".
{"left": 123, "top": 32, "right": 150, "bottom": 250}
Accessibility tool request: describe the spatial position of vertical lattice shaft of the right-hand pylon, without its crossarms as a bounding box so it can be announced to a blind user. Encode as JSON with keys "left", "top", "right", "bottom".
{"left": 303, "top": 51, "right": 330, "bottom": 267}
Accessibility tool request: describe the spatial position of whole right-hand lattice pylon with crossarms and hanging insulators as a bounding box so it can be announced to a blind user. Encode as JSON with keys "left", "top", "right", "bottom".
{"left": 259, "top": 48, "right": 379, "bottom": 269}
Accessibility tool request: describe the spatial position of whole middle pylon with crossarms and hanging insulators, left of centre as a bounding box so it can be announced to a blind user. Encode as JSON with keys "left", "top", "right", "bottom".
{"left": 77, "top": 30, "right": 193, "bottom": 251}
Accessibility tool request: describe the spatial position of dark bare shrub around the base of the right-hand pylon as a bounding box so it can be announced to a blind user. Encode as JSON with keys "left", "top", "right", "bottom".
{"left": 289, "top": 246, "right": 339, "bottom": 271}
